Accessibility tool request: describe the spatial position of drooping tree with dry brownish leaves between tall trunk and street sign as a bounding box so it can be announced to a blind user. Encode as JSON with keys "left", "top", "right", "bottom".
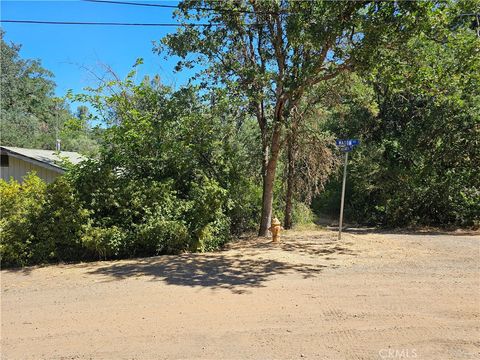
{"left": 284, "top": 76, "right": 344, "bottom": 229}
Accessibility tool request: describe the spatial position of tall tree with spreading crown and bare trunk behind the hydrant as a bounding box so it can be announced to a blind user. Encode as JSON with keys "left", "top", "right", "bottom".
{"left": 162, "top": 0, "right": 440, "bottom": 236}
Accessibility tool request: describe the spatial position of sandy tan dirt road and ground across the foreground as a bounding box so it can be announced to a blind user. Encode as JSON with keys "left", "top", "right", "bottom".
{"left": 1, "top": 231, "right": 480, "bottom": 359}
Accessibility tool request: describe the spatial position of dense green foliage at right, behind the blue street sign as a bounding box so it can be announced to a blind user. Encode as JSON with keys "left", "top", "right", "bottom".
{"left": 319, "top": 11, "right": 480, "bottom": 226}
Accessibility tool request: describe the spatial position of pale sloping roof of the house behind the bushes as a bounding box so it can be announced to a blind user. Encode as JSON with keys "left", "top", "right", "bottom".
{"left": 0, "top": 146, "right": 85, "bottom": 172}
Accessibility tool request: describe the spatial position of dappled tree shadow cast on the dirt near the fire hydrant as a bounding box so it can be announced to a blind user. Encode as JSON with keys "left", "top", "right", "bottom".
{"left": 89, "top": 233, "right": 353, "bottom": 293}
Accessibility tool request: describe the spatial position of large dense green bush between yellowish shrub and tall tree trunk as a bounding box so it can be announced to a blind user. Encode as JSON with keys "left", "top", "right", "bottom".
{"left": 63, "top": 69, "right": 260, "bottom": 258}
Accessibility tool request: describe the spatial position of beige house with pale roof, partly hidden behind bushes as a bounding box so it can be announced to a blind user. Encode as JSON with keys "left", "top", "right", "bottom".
{"left": 0, "top": 146, "right": 85, "bottom": 183}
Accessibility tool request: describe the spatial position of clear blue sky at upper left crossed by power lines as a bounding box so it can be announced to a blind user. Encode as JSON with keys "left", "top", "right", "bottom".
{"left": 1, "top": 0, "right": 191, "bottom": 96}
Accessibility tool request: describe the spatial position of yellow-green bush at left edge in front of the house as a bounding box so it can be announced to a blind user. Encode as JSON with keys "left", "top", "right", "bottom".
{"left": 0, "top": 173, "right": 93, "bottom": 266}
